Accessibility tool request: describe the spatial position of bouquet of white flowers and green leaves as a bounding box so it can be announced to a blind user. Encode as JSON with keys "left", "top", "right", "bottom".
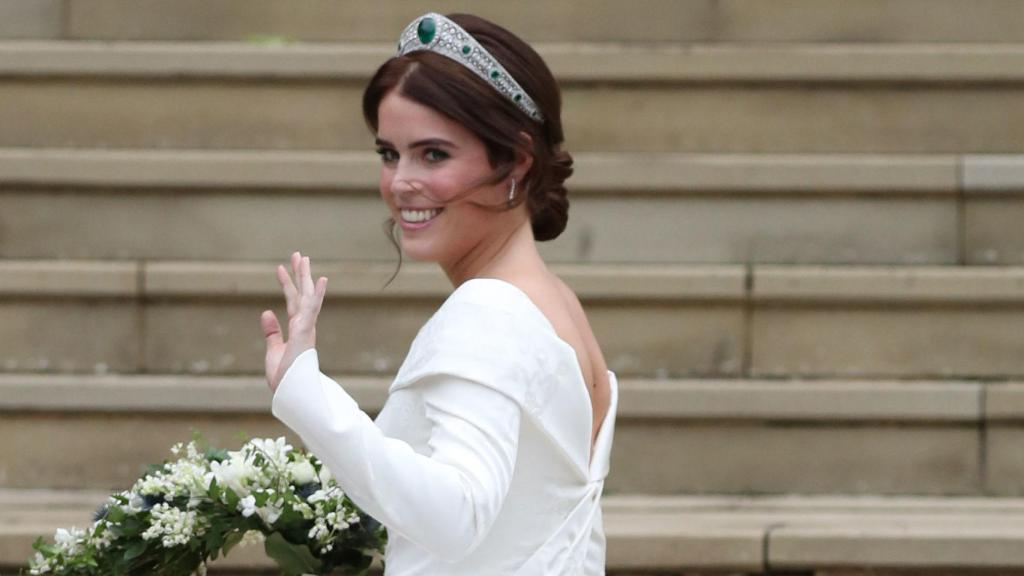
{"left": 29, "top": 437, "right": 387, "bottom": 576}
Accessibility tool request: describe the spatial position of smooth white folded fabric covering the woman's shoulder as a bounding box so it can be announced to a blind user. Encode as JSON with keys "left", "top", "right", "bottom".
{"left": 390, "top": 279, "right": 543, "bottom": 406}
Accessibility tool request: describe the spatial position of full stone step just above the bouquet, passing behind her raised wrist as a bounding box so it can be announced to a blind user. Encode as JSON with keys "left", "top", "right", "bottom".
{"left": 0, "top": 371, "right": 1024, "bottom": 496}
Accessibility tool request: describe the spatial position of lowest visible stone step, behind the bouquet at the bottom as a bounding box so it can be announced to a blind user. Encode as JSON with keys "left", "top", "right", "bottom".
{"left": 0, "top": 490, "right": 1024, "bottom": 576}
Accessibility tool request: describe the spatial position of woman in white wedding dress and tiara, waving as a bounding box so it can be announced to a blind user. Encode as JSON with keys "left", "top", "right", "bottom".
{"left": 261, "top": 13, "right": 617, "bottom": 576}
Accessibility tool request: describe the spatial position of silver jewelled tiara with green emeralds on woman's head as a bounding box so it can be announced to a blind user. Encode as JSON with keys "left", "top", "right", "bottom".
{"left": 398, "top": 12, "right": 544, "bottom": 122}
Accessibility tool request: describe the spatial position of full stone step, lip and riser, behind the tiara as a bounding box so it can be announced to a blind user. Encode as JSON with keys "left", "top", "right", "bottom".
{"left": 0, "top": 41, "right": 1024, "bottom": 154}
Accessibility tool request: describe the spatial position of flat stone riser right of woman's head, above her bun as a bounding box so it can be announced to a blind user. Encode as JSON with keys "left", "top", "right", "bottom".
{"left": 563, "top": 85, "right": 1024, "bottom": 154}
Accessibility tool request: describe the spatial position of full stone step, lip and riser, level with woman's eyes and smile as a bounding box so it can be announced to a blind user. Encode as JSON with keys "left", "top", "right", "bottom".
{"left": 0, "top": 149, "right": 1024, "bottom": 264}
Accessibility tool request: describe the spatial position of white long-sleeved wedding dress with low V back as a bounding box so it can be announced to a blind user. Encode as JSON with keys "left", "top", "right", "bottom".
{"left": 272, "top": 278, "right": 618, "bottom": 576}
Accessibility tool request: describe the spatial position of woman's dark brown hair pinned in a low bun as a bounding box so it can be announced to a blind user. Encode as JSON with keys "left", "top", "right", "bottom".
{"left": 362, "top": 14, "right": 572, "bottom": 282}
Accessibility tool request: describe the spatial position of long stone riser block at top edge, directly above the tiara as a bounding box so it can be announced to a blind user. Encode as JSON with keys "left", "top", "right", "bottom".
{"left": 61, "top": 0, "right": 709, "bottom": 41}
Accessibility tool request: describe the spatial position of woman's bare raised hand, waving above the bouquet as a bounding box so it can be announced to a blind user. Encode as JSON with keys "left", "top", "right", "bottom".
{"left": 260, "top": 252, "right": 327, "bottom": 390}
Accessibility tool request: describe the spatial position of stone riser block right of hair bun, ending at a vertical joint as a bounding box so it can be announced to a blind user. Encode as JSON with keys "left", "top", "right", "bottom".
{"left": 573, "top": 195, "right": 957, "bottom": 263}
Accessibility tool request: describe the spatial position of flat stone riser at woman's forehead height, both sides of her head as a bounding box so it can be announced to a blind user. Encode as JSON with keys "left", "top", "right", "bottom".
{"left": 0, "top": 79, "right": 1024, "bottom": 154}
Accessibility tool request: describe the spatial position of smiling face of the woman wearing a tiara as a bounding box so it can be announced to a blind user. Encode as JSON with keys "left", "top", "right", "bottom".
{"left": 377, "top": 90, "right": 525, "bottom": 265}
